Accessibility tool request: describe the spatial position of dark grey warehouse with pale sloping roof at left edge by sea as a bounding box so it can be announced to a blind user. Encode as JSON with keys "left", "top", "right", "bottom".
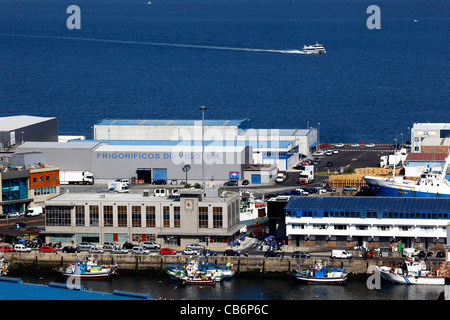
{"left": 0, "top": 115, "right": 58, "bottom": 150}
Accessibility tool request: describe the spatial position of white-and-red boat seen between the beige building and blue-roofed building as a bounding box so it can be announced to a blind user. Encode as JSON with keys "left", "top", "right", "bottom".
{"left": 239, "top": 191, "right": 269, "bottom": 227}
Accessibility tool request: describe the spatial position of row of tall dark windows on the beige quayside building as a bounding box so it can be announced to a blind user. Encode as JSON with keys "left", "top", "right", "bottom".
{"left": 46, "top": 205, "right": 223, "bottom": 228}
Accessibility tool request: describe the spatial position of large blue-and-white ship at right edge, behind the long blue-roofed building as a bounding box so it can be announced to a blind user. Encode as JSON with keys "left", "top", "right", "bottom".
{"left": 362, "top": 156, "right": 450, "bottom": 198}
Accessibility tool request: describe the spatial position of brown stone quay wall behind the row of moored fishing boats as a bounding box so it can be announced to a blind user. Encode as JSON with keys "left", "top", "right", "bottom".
{"left": 5, "top": 251, "right": 445, "bottom": 275}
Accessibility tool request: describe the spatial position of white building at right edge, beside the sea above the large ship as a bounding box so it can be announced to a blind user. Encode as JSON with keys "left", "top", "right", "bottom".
{"left": 411, "top": 123, "right": 450, "bottom": 154}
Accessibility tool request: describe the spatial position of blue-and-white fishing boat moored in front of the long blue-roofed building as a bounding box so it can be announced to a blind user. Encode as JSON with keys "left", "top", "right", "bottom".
{"left": 289, "top": 261, "right": 348, "bottom": 284}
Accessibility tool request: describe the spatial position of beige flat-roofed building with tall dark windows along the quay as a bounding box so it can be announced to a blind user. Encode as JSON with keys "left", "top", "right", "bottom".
{"left": 44, "top": 188, "right": 241, "bottom": 248}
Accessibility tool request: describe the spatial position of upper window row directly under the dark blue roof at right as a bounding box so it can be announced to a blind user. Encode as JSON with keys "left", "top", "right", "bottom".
{"left": 286, "top": 210, "right": 450, "bottom": 220}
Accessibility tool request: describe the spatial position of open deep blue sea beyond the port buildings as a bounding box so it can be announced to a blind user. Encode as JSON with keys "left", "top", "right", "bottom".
{"left": 0, "top": 0, "right": 450, "bottom": 143}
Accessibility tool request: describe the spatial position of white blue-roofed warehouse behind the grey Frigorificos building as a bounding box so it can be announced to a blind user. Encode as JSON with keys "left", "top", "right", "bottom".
{"left": 94, "top": 119, "right": 317, "bottom": 170}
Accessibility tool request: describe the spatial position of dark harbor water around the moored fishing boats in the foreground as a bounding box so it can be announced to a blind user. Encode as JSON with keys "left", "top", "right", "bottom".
{"left": 10, "top": 271, "right": 444, "bottom": 301}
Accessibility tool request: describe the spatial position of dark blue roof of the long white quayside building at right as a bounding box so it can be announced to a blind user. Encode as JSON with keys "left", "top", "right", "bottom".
{"left": 284, "top": 196, "right": 450, "bottom": 212}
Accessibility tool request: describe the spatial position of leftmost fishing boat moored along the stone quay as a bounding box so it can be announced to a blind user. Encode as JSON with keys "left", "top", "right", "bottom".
{"left": 54, "top": 257, "right": 118, "bottom": 279}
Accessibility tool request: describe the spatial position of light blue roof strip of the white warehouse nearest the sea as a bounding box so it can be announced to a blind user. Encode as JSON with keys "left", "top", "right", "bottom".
{"left": 97, "top": 119, "right": 248, "bottom": 127}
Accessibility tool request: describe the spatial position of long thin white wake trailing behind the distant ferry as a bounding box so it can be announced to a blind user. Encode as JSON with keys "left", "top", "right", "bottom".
{"left": 0, "top": 33, "right": 303, "bottom": 54}
